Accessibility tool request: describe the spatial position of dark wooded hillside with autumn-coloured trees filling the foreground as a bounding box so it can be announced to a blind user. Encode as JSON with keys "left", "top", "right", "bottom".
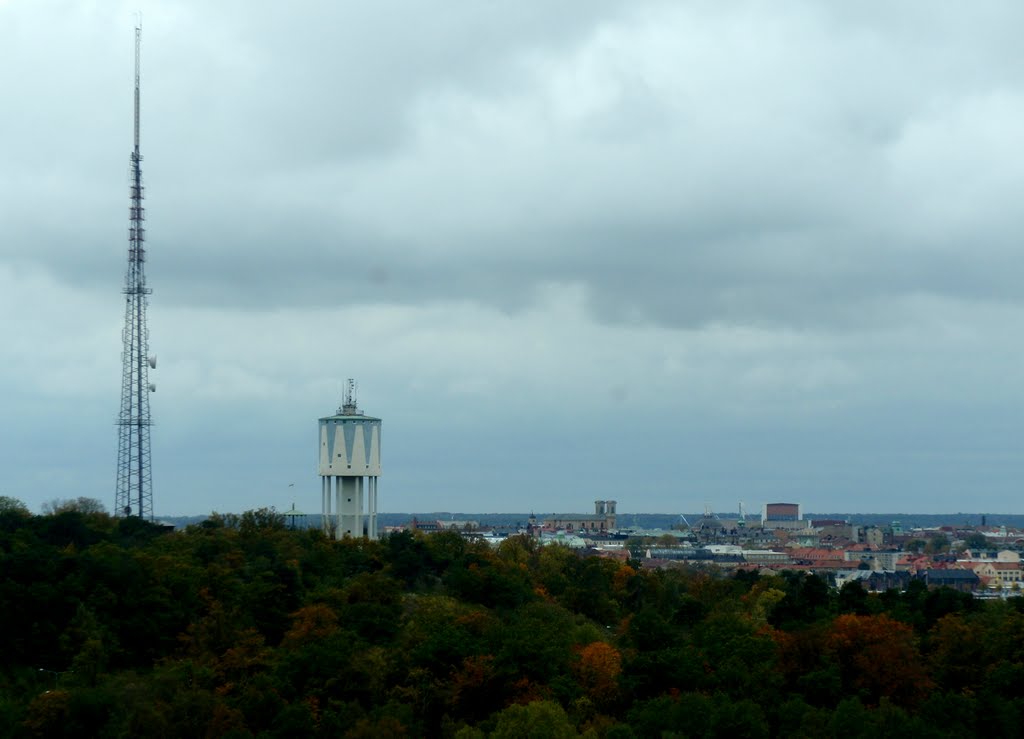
{"left": 0, "top": 497, "right": 1024, "bottom": 739}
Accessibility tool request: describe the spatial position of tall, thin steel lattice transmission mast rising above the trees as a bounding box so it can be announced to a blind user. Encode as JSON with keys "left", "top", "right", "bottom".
{"left": 114, "top": 26, "right": 157, "bottom": 519}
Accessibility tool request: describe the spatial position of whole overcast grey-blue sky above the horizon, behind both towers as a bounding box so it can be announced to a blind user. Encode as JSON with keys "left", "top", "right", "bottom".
{"left": 0, "top": 0, "right": 1024, "bottom": 517}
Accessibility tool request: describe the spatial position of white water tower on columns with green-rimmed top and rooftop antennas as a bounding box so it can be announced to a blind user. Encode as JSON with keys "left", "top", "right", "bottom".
{"left": 319, "top": 380, "right": 381, "bottom": 539}
